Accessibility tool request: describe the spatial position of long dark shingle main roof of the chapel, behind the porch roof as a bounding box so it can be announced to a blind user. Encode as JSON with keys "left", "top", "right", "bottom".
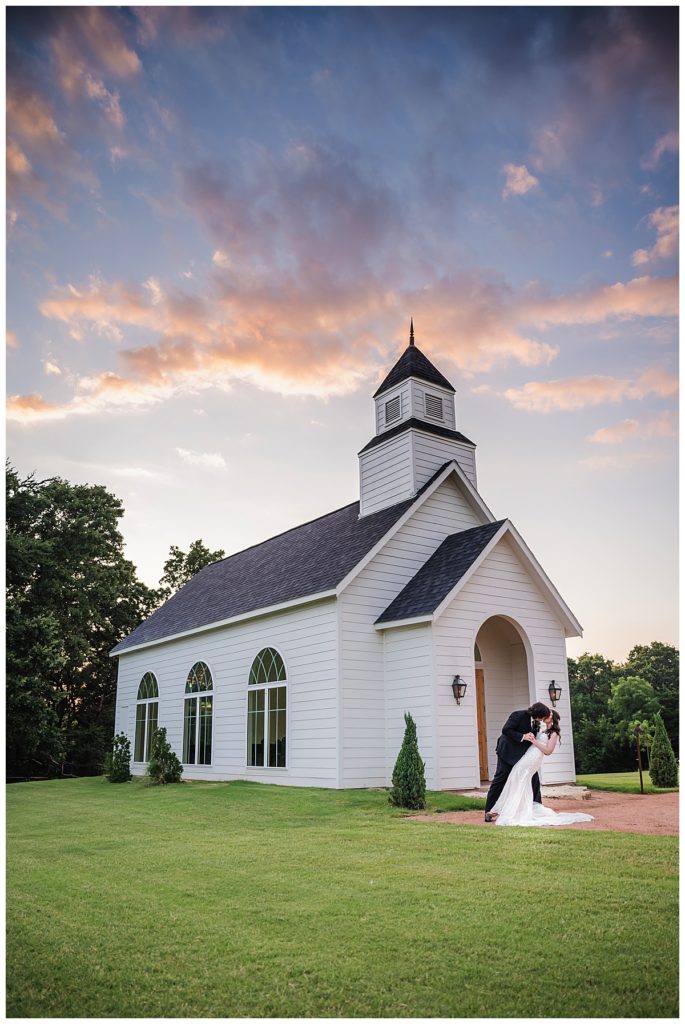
{"left": 111, "top": 462, "right": 456, "bottom": 654}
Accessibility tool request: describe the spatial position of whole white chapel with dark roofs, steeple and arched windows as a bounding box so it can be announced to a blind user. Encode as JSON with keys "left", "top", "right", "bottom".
{"left": 112, "top": 326, "right": 582, "bottom": 790}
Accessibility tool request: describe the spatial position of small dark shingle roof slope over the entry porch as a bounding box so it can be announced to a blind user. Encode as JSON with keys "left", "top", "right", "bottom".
{"left": 376, "top": 519, "right": 506, "bottom": 623}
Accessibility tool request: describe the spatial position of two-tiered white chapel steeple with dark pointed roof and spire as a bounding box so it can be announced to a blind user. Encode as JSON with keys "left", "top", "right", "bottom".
{"left": 359, "top": 317, "right": 476, "bottom": 516}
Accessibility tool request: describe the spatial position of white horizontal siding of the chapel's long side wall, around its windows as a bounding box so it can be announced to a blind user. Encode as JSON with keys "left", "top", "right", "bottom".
{"left": 116, "top": 600, "right": 338, "bottom": 787}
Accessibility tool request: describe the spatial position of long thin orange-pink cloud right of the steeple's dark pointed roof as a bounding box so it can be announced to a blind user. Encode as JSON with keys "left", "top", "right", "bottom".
{"left": 504, "top": 369, "right": 678, "bottom": 413}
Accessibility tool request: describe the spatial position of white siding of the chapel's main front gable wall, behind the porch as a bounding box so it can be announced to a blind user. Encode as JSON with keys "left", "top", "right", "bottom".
{"left": 340, "top": 478, "right": 482, "bottom": 785}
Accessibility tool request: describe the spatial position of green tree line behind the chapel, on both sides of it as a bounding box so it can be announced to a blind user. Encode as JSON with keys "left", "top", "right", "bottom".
{"left": 6, "top": 463, "right": 678, "bottom": 778}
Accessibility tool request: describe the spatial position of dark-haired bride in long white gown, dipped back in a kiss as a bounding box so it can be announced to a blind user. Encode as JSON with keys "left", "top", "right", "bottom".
{"left": 491, "top": 711, "right": 594, "bottom": 825}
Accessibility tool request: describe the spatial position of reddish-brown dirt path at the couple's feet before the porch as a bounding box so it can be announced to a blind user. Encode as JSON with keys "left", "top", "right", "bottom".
{"left": 412, "top": 790, "right": 678, "bottom": 836}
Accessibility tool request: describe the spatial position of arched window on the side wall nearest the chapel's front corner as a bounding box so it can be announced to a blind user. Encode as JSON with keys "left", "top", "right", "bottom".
{"left": 248, "top": 647, "right": 287, "bottom": 768}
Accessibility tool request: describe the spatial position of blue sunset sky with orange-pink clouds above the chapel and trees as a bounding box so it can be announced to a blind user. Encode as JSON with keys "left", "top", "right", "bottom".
{"left": 6, "top": 7, "right": 678, "bottom": 660}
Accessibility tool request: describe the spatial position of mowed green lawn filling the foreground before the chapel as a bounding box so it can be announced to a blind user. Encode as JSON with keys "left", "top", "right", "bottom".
{"left": 7, "top": 779, "right": 678, "bottom": 1017}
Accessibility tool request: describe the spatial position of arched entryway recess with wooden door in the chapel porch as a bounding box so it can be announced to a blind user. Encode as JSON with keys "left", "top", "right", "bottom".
{"left": 473, "top": 615, "right": 534, "bottom": 782}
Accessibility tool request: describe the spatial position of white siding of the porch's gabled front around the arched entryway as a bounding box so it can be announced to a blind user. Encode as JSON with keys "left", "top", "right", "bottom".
{"left": 433, "top": 539, "right": 575, "bottom": 788}
